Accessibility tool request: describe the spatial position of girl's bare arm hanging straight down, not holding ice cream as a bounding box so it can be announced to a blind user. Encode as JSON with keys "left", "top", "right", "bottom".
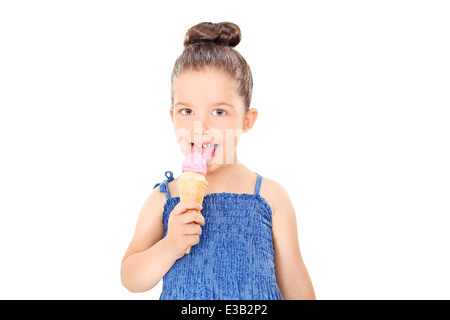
{"left": 261, "top": 179, "right": 316, "bottom": 300}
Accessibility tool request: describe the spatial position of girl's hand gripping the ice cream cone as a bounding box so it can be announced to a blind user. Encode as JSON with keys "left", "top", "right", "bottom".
{"left": 164, "top": 200, "right": 205, "bottom": 259}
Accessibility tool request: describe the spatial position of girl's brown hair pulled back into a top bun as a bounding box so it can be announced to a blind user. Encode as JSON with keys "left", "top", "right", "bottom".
{"left": 171, "top": 22, "right": 253, "bottom": 111}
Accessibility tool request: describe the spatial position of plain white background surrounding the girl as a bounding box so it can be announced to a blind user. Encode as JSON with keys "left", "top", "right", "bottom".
{"left": 0, "top": 0, "right": 450, "bottom": 299}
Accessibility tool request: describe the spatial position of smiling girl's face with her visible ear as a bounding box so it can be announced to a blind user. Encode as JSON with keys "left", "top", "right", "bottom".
{"left": 170, "top": 69, "right": 257, "bottom": 165}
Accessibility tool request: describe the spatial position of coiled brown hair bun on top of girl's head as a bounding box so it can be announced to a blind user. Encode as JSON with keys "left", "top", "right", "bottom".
{"left": 184, "top": 22, "right": 241, "bottom": 48}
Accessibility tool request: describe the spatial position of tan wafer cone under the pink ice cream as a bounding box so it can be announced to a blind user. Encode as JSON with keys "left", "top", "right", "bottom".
{"left": 177, "top": 171, "right": 208, "bottom": 253}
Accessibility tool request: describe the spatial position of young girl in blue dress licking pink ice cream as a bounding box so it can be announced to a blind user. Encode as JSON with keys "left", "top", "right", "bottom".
{"left": 121, "top": 22, "right": 315, "bottom": 300}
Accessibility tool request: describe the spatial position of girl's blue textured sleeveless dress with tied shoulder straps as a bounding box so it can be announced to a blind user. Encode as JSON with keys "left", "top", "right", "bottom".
{"left": 154, "top": 171, "right": 281, "bottom": 300}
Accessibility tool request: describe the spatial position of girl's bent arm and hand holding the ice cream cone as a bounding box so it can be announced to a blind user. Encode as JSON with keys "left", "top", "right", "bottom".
{"left": 121, "top": 185, "right": 204, "bottom": 292}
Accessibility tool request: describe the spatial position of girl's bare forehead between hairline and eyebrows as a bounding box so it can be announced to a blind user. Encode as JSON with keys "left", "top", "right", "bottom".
{"left": 174, "top": 69, "right": 239, "bottom": 104}
